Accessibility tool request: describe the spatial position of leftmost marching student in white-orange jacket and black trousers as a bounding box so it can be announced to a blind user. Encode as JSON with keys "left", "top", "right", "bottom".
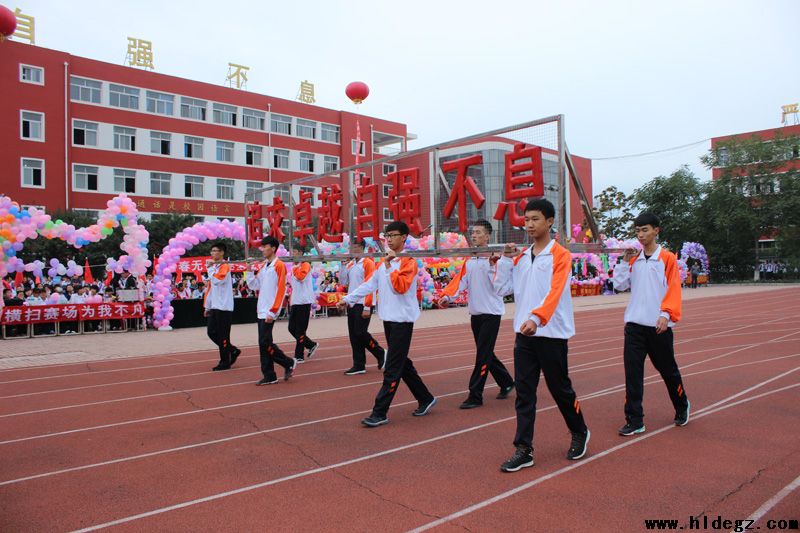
{"left": 203, "top": 242, "right": 242, "bottom": 371}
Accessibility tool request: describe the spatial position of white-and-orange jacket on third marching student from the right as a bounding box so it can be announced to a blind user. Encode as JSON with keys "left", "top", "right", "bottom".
{"left": 442, "top": 257, "right": 506, "bottom": 316}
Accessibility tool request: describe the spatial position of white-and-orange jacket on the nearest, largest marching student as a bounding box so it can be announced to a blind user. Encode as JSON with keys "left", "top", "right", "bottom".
{"left": 494, "top": 240, "right": 575, "bottom": 339}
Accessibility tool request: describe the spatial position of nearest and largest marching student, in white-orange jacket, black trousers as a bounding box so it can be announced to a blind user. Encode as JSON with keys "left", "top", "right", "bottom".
{"left": 491, "top": 198, "right": 590, "bottom": 472}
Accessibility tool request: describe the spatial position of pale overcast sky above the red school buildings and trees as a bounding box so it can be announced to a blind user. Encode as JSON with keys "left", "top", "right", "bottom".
{"left": 17, "top": 0, "right": 800, "bottom": 194}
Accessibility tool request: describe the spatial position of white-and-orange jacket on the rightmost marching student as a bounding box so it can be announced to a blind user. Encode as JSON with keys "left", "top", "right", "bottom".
{"left": 612, "top": 246, "right": 681, "bottom": 327}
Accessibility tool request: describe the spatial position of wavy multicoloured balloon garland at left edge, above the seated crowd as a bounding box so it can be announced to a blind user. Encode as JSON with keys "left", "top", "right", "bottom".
{"left": 0, "top": 194, "right": 150, "bottom": 277}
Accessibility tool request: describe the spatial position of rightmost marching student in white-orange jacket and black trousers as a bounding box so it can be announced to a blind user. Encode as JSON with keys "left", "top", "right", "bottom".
{"left": 614, "top": 212, "right": 690, "bottom": 436}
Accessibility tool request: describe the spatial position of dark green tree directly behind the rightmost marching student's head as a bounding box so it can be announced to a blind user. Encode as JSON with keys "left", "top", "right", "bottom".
{"left": 630, "top": 165, "right": 703, "bottom": 251}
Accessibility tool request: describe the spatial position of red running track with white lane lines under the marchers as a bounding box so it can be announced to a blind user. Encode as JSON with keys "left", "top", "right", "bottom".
{"left": 0, "top": 289, "right": 800, "bottom": 531}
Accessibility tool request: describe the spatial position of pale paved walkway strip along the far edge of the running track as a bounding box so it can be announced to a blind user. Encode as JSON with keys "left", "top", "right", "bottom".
{"left": 0, "top": 284, "right": 800, "bottom": 369}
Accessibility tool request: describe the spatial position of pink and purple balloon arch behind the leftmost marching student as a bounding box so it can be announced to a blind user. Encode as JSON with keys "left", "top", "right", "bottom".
{"left": 152, "top": 220, "right": 245, "bottom": 329}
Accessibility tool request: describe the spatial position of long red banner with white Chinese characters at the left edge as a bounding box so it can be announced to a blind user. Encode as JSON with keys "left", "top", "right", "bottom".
{"left": 0, "top": 302, "right": 144, "bottom": 326}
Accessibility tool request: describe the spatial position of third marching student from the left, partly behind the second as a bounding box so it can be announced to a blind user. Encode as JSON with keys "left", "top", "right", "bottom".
{"left": 289, "top": 243, "right": 319, "bottom": 363}
